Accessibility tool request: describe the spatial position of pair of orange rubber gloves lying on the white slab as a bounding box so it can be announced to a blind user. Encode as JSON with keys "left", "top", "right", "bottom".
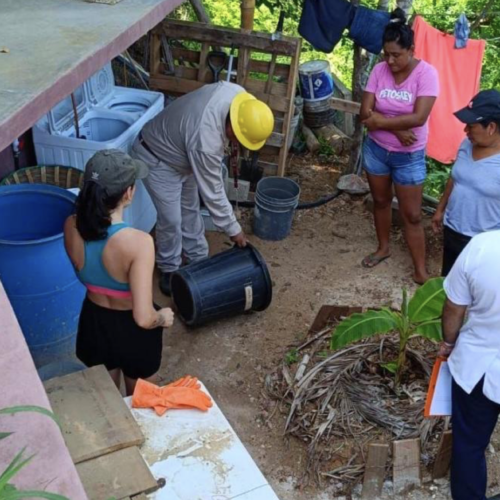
{"left": 132, "top": 377, "right": 213, "bottom": 416}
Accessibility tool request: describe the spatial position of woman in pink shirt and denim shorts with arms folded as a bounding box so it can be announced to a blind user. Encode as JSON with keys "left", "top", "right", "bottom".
{"left": 361, "top": 9, "right": 439, "bottom": 283}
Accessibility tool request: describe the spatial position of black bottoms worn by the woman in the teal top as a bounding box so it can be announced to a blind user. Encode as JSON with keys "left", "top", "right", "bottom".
{"left": 76, "top": 298, "right": 163, "bottom": 379}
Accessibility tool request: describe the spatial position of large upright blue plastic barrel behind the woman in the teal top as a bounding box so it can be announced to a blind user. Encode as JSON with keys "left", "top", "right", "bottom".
{"left": 0, "top": 184, "right": 85, "bottom": 367}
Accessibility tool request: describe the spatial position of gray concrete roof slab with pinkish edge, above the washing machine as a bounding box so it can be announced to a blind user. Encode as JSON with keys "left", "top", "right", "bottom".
{"left": 0, "top": 0, "right": 184, "bottom": 151}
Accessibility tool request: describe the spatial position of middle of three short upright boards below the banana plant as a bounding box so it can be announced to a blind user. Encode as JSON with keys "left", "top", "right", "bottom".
{"left": 393, "top": 439, "right": 421, "bottom": 494}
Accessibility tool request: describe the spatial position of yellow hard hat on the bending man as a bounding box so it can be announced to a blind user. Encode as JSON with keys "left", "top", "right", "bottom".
{"left": 230, "top": 92, "right": 274, "bottom": 151}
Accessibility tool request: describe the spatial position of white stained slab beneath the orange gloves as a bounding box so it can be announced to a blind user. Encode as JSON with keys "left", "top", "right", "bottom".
{"left": 125, "top": 385, "right": 279, "bottom": 500}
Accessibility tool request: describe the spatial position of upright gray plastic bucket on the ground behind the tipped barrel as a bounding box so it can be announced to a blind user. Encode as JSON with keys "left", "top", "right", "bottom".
{"left": 253, "top": 177, "right": 300, "bottom": 241}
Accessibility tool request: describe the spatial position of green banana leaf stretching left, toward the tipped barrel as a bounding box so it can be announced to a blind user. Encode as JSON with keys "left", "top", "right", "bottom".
{"left": 330, "top": 309, "right": 397, "bottom": 349}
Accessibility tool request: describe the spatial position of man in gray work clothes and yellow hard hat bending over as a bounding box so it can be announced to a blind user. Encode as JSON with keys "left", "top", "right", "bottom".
{"left": 131, "top": 82, "right": 274, "bottom": 295}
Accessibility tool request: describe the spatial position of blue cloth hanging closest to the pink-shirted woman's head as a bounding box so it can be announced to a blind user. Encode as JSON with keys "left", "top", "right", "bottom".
{"left": 349, "top": 6, "right": 391, "bottom": 54}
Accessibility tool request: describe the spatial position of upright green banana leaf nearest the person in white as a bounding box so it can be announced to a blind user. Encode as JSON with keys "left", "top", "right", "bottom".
{"left": 408, "top": 278, "right": 446, "bottom": 324}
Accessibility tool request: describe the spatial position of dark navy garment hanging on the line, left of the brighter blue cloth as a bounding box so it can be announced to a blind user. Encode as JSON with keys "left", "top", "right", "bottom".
{"left": 299, "top": 0, "right": 356, "bottom": 52}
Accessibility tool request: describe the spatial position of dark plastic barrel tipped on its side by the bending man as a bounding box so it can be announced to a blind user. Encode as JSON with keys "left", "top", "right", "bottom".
{"left": 170, "top": 245, "right": 272, "bottom": 326}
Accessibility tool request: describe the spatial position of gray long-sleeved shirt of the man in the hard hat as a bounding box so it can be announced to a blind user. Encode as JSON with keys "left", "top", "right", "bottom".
{"left": 142, "top": 82, "right": 245, "bottom": 236}
